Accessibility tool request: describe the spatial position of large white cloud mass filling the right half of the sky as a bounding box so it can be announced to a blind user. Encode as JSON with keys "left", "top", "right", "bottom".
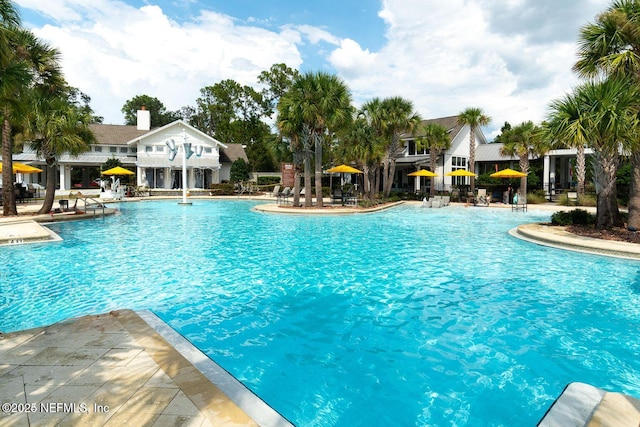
{"left": 332, "top": 0, "right": 607, "bottom": 134}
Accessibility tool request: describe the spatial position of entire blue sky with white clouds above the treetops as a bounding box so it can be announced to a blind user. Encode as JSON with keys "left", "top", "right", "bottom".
{"left": 17, "top": 0, "right": 610, "bottom": 139}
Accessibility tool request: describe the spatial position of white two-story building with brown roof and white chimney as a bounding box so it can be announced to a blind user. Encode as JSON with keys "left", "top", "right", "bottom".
{"left": 13, "top": 110, "right": 248, "bottom": 190}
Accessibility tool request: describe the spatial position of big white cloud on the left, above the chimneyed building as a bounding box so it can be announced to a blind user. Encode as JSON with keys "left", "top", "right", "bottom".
{"left": 25, "top": 0, "right": 302, "bottom": 123}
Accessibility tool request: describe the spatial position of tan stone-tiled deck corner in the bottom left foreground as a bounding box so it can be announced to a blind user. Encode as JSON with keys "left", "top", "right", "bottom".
{"left": 0, "top": 310, "right": 292, "bottom": 427}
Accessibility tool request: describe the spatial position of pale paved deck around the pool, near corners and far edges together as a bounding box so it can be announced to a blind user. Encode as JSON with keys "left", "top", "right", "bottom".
{"left": 0, "top": 196, "right": 640, "bottom": 427}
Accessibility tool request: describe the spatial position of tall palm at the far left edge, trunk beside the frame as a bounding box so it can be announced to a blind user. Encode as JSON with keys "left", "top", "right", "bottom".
{"left": 0, "top": 25, "right": 64, "bottom": 215}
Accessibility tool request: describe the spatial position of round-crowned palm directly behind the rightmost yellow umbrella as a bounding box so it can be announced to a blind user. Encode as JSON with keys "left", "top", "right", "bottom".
{"left": 500, "top": 121, "right": 549, "bottom": 197}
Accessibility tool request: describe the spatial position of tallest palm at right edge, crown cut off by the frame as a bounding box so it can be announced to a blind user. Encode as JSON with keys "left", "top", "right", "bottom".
{"left": 573, "top": 0, "right": 640, "bottom": 229}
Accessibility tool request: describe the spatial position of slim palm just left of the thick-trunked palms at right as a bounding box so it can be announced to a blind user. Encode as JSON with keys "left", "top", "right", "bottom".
{"left": 543, "top": 93, "right": 588, "bottom": 196}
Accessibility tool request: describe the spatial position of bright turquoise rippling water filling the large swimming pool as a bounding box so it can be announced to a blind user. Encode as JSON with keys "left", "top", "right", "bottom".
{"left": 0, "top": 201, "right": 640, "bottom": 426}
